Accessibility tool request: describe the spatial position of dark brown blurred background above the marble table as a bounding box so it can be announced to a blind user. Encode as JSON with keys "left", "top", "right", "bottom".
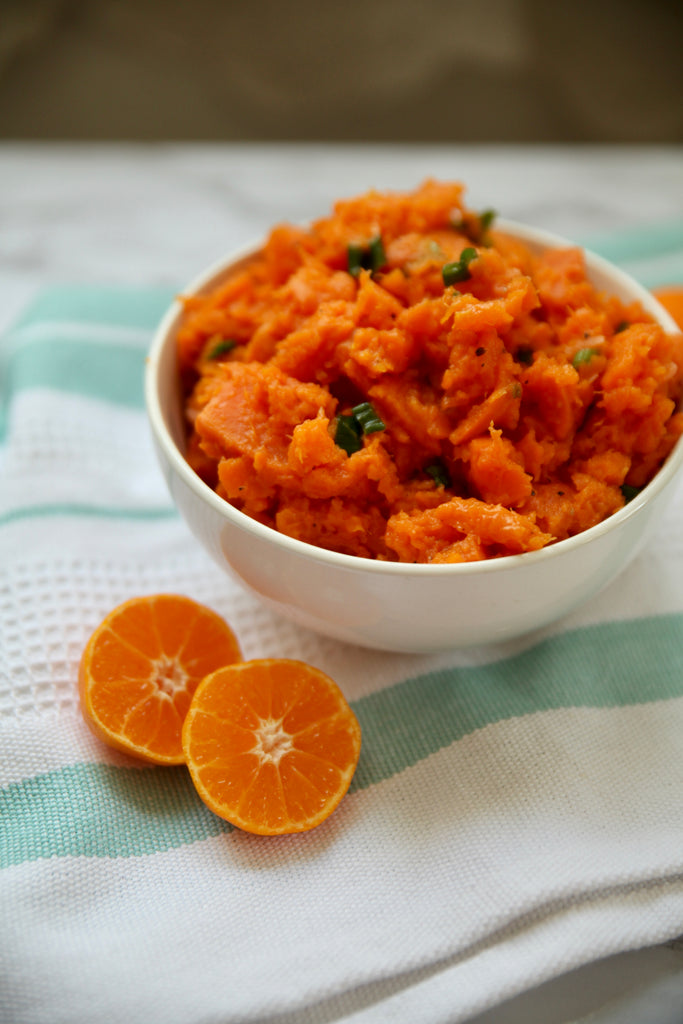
{"left": 0, "top": 0, "right": 683, "bottom": 144}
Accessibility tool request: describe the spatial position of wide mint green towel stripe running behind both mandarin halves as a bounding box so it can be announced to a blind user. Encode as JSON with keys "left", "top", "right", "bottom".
{"left": 0, "top": 615, "right": 683, "bottom": 866}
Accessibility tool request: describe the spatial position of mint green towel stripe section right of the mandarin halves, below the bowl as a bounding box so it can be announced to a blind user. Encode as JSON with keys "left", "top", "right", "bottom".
{"left": 353, "top": 615, "right": 683, "bottom": 790}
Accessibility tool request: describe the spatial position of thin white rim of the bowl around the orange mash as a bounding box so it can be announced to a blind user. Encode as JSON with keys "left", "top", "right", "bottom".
{"left": 144, "top": 217, "right": 683, "bottom": 579}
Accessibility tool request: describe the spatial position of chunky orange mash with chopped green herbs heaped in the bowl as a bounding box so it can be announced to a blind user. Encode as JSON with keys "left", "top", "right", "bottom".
{"left": 177, "top": 180, "right": 683, "bottom": 562}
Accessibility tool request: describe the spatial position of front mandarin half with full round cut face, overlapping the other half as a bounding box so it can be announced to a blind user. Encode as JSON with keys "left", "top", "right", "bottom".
{"left": 182, "top": 658, "right": 360, "bottom": 836}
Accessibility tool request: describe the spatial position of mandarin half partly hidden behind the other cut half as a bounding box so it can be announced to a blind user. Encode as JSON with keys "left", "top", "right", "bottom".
{"left": 79, "top": 594, "right": 242, "bottom": 764}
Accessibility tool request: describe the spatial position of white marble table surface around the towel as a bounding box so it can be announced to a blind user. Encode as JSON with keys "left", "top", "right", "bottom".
{"left": 0, "top": 143, "right": 683, "bottom": 1024}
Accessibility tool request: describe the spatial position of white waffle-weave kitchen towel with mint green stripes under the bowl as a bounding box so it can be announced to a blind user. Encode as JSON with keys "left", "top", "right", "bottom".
{"left": 0, "top": 226, "right": 683, "bottom": 1024}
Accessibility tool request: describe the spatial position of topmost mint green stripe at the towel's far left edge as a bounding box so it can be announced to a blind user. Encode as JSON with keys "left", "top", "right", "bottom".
{"left": 16, "top": 285, "right": 177, "bottom": 329}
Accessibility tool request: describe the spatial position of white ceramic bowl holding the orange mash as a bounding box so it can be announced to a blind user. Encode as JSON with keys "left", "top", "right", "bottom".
{"left": 145, "top": 221, "right": 683, "bottom": 652}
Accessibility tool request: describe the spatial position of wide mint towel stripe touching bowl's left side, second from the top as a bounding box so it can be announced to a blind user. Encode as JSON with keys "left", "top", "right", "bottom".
{"left": 5, "top": 340, "right": 145, "bottom": 409}
